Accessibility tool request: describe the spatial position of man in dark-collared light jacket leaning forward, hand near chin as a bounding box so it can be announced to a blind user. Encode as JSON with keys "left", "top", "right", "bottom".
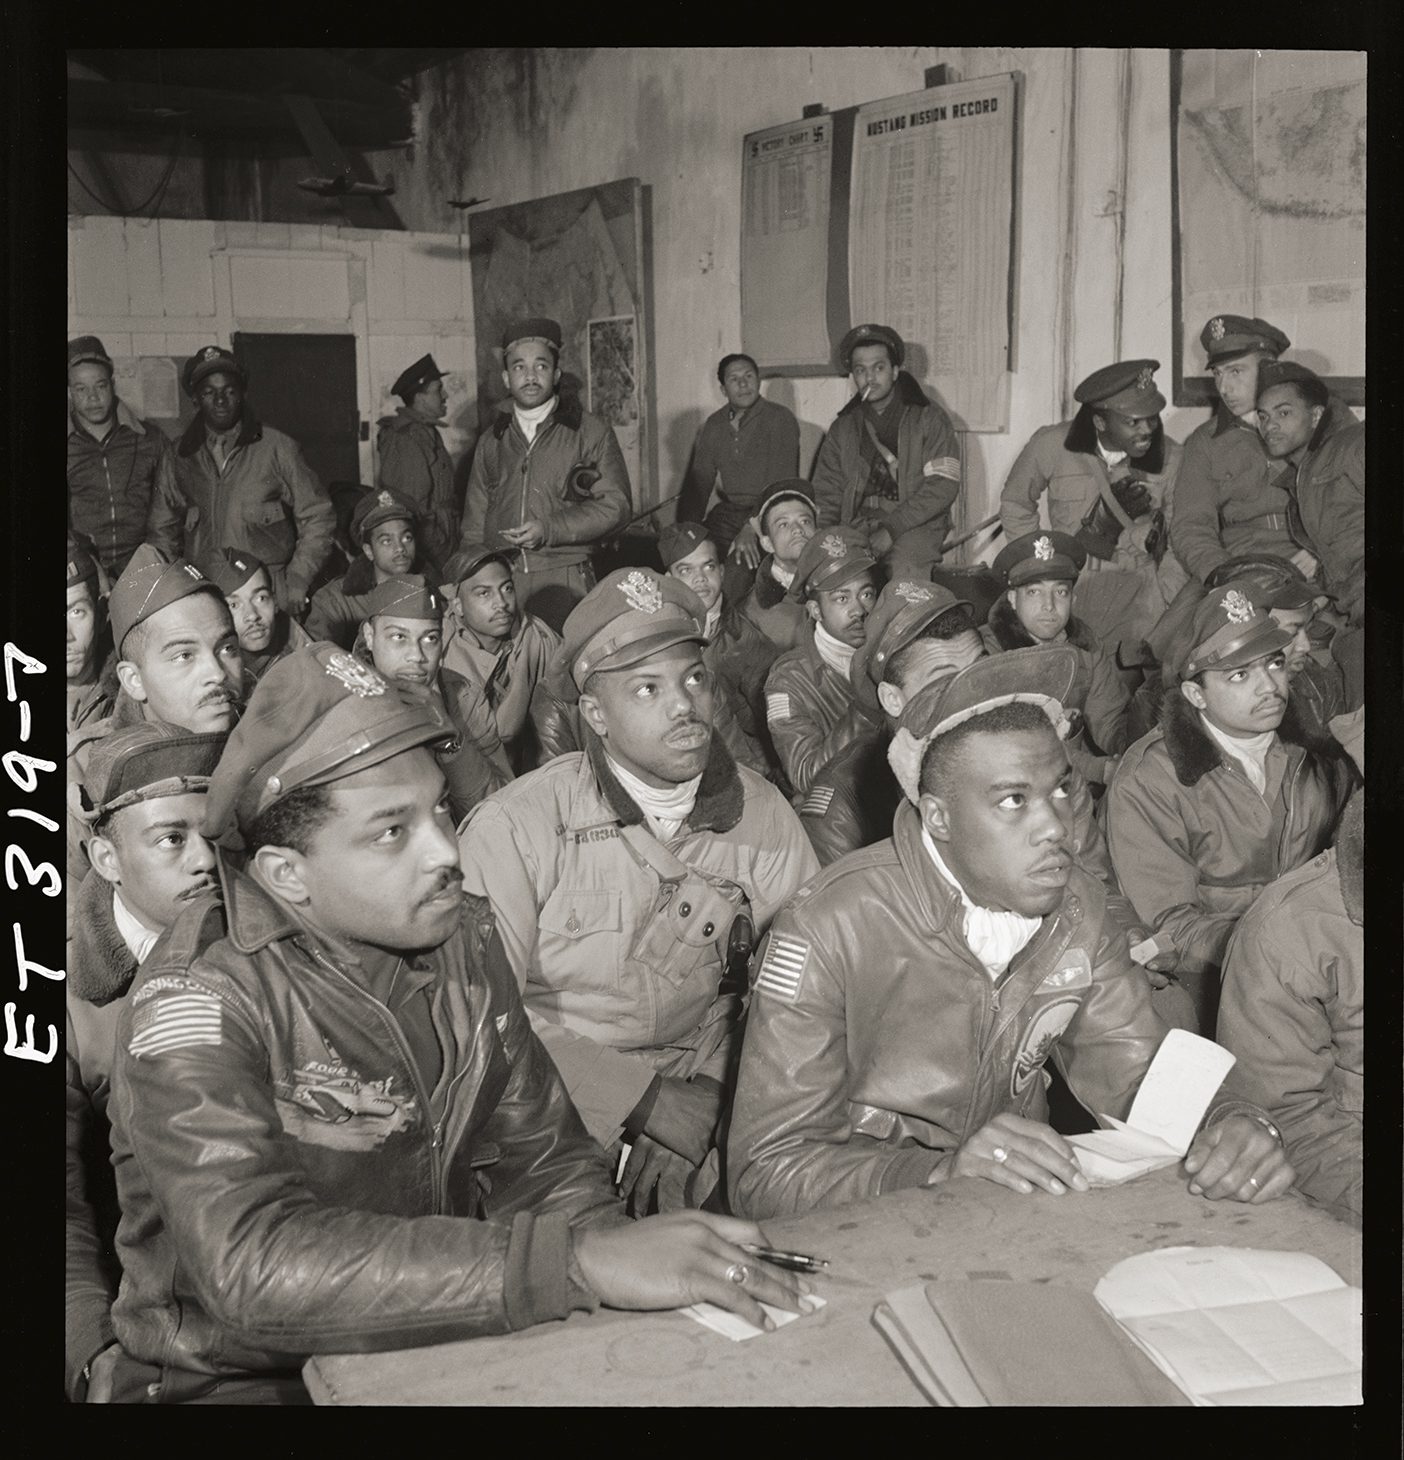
{"left": 1000, "top": 359, "right": 1185, "bottom": 653}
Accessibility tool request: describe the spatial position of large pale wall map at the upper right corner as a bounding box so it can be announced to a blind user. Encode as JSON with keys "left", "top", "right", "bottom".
{"left": 1175, "top": 50, "right": 1366, "bottom": 404}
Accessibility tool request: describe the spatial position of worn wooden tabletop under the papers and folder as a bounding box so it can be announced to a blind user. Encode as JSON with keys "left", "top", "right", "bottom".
{"left": 304, "top": 1168, "right": 1360, "bottom": 1406}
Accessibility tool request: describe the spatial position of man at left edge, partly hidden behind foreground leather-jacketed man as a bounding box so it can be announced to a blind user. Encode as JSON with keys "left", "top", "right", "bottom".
{"left": 64, "top": 724, "right": 225, "bottom": 1402}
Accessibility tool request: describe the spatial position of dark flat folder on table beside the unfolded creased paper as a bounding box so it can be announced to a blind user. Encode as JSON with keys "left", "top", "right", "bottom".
{"left": 873, "top": 1280, "right": 1187, "bottom": 1409}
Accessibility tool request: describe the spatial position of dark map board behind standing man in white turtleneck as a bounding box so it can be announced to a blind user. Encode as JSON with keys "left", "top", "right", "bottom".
{"left": 468, "top": 178, "right": 658, "bottom": 511}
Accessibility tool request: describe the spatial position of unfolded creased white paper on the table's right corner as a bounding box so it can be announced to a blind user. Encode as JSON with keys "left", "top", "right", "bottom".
{"left": 1096, "top": 1247, "right": 1362, "bottom": 1405}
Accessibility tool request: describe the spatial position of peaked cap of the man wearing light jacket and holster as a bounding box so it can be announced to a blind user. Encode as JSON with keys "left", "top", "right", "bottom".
{"left": 553, "top": 568, "right": 706, "bottom": 698}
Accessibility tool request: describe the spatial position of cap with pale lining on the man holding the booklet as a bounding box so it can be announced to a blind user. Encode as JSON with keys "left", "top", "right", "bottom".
{"left": 887, "top": 644, "right": 1081, "bottom": 804}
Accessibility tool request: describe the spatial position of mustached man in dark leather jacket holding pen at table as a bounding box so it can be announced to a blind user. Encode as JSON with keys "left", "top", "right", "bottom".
{"left": 103, "top": 644, "right": 798, "bottom": 1403}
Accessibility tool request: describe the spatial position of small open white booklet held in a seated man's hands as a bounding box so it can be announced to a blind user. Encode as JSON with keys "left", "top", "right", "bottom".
{"left": 1067, "top": 1029, "right": 1233, "bottom": 1186}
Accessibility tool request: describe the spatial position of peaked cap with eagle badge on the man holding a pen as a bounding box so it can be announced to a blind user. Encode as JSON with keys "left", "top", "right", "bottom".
{"left": 204, "top": 641, "right": 454, "bottom": 838}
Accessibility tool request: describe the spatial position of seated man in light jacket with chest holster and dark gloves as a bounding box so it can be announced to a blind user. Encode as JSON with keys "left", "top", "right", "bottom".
{"left": 458, "top": 568, "right": 816, "bottom": 1213}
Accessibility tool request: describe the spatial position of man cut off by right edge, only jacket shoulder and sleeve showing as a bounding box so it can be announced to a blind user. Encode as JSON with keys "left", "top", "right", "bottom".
{"left": 1217, "top": 710, "right": 1365, "bottom": 1225}
